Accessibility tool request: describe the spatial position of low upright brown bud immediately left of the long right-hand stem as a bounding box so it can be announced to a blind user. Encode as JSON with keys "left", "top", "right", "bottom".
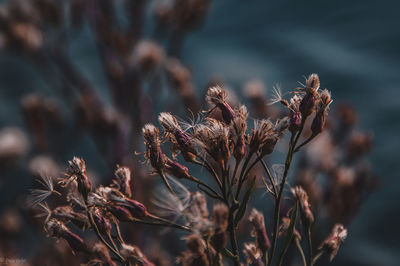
{"left": 249, "top": 209, "right": 271, "bottom": 253}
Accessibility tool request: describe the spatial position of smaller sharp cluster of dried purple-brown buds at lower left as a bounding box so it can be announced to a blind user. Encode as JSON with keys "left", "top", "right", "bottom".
{"left": 31, "top": 157, "right": 176, "bottom": 266}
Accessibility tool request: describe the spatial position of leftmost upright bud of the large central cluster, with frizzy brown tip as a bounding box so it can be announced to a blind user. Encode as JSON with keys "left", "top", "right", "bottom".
{"left": 142, "top": 124, "right": 165, "bottom": 171}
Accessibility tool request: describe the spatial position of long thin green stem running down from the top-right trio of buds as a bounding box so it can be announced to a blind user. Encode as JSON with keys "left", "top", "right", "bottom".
{"left": 268, "top": 125, "right": 305, "bottom": 265}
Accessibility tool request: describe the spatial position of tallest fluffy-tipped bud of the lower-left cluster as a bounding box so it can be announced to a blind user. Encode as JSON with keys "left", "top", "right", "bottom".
{"left": 67, "top": 157, "right": 92, "bottom": 200}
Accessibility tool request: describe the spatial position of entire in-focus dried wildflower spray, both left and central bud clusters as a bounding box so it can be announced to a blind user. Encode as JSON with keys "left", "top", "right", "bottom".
{"left": 27, "top": 74, "right": 354, "bottom": 265}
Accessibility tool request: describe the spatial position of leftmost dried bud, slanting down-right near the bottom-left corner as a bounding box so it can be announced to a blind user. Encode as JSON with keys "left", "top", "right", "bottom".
{"left": 46, "top": 219, "right": 88, "bottom": 255}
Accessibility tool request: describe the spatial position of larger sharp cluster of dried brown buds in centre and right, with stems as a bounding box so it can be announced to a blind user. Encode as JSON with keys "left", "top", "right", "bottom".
{"left": 142, "top": 74, "right": 346, "bottom": 265}
